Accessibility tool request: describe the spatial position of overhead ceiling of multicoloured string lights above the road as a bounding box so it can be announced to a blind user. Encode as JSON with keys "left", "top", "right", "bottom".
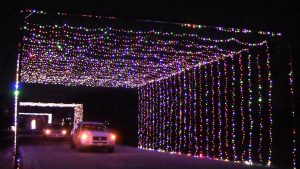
{"left": 21, "top": 20, "right": 265, "bottom": 87}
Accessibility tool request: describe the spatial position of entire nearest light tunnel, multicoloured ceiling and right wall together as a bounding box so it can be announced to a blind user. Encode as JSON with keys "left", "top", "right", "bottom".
{"left": 18, "top": 10, "right": 296, "bottom": 169}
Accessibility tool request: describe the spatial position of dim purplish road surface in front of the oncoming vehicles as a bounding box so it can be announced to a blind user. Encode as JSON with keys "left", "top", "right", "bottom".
{"left": 20, "top": 136, "right": 270, "bottom": 169}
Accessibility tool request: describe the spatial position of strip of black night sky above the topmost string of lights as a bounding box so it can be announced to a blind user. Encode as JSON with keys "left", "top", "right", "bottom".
{"left": 1, "top": 0, "right": 299, "bottom": 32}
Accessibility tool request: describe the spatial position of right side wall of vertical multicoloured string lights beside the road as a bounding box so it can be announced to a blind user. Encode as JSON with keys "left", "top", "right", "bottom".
{"left": 138, "top": 45, "right": 272, "bottom": 165}
